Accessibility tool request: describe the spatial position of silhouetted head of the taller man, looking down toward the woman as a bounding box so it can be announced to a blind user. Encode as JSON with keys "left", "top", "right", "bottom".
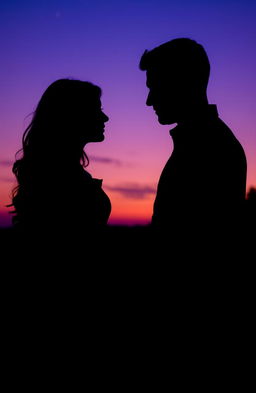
{"left": 140, "top": 38, "right": 210, "bottom": 124}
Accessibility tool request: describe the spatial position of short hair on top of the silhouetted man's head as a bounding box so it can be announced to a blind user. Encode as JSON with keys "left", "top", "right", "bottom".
{"left": 139, "top": 38, "right": 210, "bottom": 88}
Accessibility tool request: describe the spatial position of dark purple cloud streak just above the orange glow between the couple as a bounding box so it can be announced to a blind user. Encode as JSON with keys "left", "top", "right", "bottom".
{"left": 104, "top": 183, "right": 156, "bottom": 199}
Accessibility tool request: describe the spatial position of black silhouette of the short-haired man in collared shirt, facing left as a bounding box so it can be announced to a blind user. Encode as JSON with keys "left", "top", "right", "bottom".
{"left": 140, "top": 38, "right": 246, "bottom": 231}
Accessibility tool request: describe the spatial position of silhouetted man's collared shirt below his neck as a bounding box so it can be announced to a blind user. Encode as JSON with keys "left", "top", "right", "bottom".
{"left": 152, "top": 105, "right": 246, "bottom": 227}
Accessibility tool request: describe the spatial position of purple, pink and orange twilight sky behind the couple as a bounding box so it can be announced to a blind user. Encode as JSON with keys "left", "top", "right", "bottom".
{"left": 0, "top": 0, "right": 256, "bottom": 226}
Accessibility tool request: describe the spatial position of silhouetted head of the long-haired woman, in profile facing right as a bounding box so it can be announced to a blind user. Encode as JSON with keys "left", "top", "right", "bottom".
{"left": 30, "top": 79, "right": 108, "bottom": 150}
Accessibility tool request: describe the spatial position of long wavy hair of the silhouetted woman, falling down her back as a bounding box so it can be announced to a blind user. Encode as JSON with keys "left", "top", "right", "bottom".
{"left": 9, "top": 79, "right": 101, "bottom": 224}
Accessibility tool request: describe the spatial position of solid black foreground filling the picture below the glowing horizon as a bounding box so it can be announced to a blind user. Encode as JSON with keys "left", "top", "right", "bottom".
{"left": 0, "top": 219, "right": 255, "bottom": 392}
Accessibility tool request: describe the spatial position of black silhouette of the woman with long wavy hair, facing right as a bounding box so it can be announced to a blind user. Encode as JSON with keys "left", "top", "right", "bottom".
{"left": 8, "top": 79, "right": 111, "bottom": 233}
